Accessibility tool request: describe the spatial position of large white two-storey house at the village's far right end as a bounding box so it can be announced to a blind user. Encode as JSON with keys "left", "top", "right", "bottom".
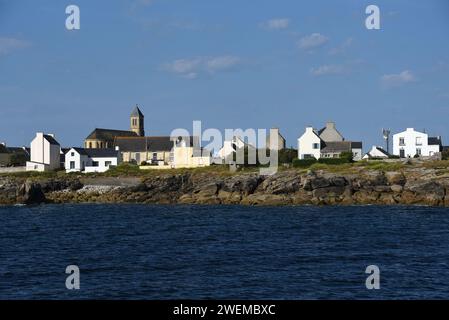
{"left": 393, "top": 128, "right": 442, "bottom": 158}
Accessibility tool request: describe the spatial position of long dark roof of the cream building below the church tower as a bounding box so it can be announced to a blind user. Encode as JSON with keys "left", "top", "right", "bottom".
{"left": 114, "top": 136, "right": 173, "bottom": 152}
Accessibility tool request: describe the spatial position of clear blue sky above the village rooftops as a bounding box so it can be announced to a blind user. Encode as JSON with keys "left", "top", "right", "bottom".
{"left": 0, "top": 0, "right": 449, "bottom": 149}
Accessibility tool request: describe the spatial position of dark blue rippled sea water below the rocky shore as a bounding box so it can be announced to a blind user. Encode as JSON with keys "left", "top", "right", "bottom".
{"left": 0, "top": 205, "right": 449, "bottom": 299}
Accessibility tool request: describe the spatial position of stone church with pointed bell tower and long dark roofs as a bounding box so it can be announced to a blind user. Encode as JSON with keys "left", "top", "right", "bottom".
{"left": 84, "top": 105, "right": 174, "bottom": 165}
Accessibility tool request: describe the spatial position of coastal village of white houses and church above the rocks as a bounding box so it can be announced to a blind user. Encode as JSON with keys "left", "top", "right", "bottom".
{"left": 0, "top": 105, "right": 449, "bottom": 173}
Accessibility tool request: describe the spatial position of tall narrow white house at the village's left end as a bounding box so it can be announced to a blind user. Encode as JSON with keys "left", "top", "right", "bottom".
{"left": 26, "top": 132, "right": 61, "bottom": 171}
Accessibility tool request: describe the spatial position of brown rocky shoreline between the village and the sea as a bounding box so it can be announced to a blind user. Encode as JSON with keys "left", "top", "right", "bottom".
{"left": 0, "top": 168, "right": 449, "bottom": 206}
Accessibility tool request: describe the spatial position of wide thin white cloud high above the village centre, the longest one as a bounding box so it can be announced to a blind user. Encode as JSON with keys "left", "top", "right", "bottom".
{"left": 164, "top": 56, "right": 241, "bottom": 79}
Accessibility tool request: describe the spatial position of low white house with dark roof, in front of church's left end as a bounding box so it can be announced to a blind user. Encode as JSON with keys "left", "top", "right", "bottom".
{"left": 65, "top": 148, "right": 121, "bottom": 173}
